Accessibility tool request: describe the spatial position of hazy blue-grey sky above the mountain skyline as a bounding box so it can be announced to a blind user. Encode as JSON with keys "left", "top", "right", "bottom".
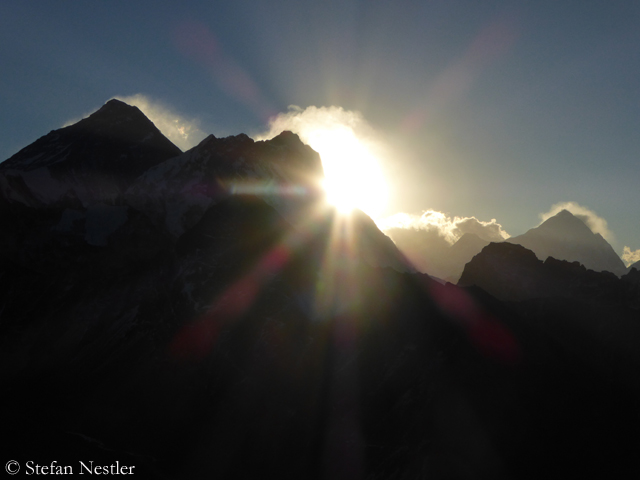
{"left": 0, "top": 0, "right": 640, "bottom": 258}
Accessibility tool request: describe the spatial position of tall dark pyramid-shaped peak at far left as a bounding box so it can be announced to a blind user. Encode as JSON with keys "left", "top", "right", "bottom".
{"left": 0, "top": 100, "right": 181, "bottom": 206}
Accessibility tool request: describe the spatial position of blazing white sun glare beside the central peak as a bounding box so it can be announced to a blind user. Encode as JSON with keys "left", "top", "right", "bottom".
{"left": 306, "top": 126, "right": 387, "bottom": 218}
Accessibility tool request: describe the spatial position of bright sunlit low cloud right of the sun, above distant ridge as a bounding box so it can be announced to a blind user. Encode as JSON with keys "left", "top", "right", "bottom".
{"left": 376, "top": 210, "right": 511, "bottom": 245}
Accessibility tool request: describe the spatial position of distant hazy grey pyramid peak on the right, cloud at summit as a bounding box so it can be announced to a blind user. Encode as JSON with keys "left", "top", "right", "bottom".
{"left": 507, "top": 210, "right": 626, "bottom": 276}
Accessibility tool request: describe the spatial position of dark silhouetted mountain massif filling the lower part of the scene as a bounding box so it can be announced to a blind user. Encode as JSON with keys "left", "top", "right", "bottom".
{"left": 0, "top": 102, "right": 640, "bottom": 479}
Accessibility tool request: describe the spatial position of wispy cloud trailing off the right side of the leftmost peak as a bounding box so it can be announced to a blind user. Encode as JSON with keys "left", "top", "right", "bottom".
{"left": 114, "top": 94, "right": 206, "bottom": 151}
